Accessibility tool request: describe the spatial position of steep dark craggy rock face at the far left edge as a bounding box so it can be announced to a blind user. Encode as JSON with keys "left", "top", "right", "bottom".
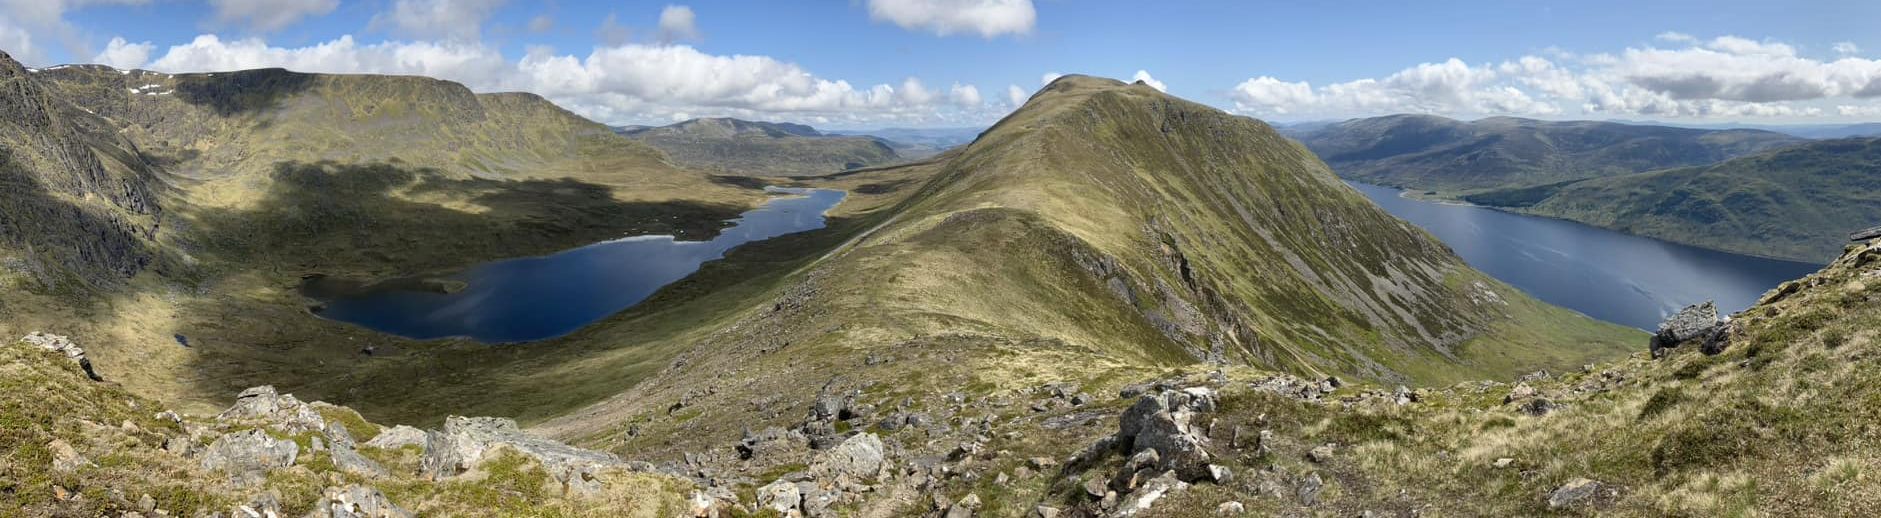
{"left": 0, "top": 53, "right": 162, "bottom": 286}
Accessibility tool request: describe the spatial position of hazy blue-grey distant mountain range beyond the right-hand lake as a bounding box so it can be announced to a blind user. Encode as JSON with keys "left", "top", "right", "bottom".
{"left": 1300, "top": 115, "right": 1804, "bottom": 192}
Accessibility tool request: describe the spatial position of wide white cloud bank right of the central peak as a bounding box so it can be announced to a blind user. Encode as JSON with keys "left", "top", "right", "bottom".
{"left": 1228, "top": 34, "right": 1881, "bottom": 119}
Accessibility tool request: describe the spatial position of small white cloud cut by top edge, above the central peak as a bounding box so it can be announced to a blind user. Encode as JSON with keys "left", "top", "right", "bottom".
{"left": 869, "top": 0, "right": 1038, "bottom": 38}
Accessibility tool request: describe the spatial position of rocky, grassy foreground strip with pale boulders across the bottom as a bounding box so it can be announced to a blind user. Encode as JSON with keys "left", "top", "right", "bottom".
{"left": 11, "top": 245, "right": 1881, "bottom": 518}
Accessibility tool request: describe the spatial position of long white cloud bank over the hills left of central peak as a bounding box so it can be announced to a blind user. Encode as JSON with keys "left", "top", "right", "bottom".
{"left": 134, "top": 34, "right": 999, "bottom": 124}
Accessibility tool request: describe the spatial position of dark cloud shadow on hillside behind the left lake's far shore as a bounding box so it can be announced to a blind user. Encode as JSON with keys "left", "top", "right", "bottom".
{"left": 192, "top": 162, "right": 743, "bottom": 273}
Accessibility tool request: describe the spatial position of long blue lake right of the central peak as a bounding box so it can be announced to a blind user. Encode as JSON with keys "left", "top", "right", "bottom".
{"left": 1351, "top": 183, "right": 1821, "bottom": 330}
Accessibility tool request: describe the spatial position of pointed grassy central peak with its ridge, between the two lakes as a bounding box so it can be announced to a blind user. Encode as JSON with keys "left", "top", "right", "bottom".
{"left": 544, "top": 77, "right": 1640, "bottom": 463}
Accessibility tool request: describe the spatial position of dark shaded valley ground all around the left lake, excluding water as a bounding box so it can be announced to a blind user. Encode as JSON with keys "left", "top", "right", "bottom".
{"left": 156, "top": 162, "right": 863, "bottom": 424}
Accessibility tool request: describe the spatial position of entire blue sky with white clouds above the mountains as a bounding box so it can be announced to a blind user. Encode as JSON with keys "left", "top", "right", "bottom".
{"left": 0, "top": 0, "right": 1881, "bottom": 128}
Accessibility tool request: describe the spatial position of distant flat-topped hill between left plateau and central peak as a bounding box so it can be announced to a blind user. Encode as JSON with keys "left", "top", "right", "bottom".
{"left": 621, "top": 119, "right": 901, "bottom": 177}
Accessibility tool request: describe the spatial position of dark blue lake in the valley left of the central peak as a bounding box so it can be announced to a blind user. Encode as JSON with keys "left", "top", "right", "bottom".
{"left": 318, "top": 188, "right": 846, "bottom": 343}
